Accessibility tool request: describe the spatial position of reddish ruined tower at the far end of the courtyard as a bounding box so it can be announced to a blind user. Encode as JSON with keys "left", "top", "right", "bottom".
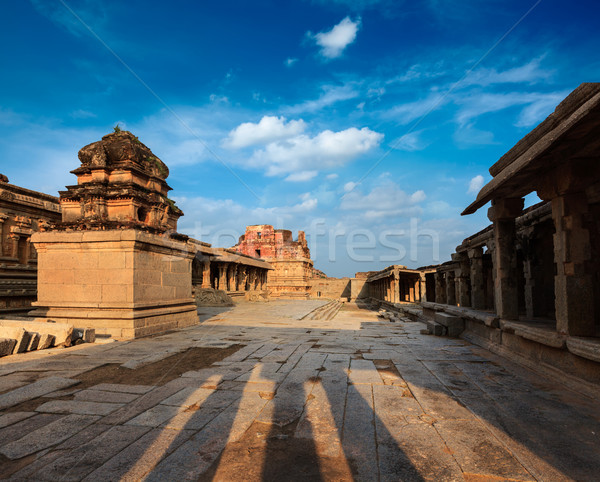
{"left": 232, "top": 224, "right": 313, "bottom": 299}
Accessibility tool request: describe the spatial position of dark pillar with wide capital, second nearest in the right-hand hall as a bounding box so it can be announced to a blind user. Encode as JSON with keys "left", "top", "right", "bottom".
{"left": 488, "top": 198, "right": 523, "bottom": 320}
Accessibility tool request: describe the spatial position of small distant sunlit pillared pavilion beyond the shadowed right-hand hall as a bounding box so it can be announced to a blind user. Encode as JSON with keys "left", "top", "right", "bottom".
{"left": 367, "top": 265, "right": 435, "bottom": 304}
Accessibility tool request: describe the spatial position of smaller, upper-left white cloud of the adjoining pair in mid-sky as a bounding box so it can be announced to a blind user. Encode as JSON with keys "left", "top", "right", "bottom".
{"left": 223, "top": 116, "right": 306, "bottom": 149}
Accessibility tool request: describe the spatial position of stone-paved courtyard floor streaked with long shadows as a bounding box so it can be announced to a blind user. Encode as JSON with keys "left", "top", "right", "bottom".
{"left": 0, "top": 301, "right": 600, "bottom": 481}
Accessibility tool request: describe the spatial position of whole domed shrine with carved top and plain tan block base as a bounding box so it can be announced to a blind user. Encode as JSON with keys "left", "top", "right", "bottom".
{"left": 31, "top": 131, "right": 198, "bottom": 339}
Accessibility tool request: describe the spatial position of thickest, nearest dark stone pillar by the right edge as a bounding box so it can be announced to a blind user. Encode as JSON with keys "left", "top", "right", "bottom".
{"left": 552, "top": 193, "right": 596, "bottom": 336}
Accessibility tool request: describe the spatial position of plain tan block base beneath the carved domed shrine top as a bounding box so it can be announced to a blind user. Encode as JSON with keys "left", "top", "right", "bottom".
{"left": 32, "top": 230, "right": 198, "bottom": 339}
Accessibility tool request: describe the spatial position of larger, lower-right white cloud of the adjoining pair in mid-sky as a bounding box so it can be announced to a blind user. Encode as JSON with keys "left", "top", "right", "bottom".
{"left": 250, "top": 127, "right": 383, "bottom": 176}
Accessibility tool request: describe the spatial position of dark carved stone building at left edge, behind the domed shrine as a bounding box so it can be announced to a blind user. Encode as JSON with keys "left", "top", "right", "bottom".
{"left": 0, "top": 174, "right": 60, "bottom": 315}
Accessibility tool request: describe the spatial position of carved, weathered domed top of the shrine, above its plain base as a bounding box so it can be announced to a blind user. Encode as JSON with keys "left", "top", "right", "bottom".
{"left": 60, "top": 131, "right": 183, "bottom": 232}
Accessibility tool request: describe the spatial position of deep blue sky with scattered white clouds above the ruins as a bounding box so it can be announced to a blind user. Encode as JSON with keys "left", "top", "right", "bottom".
{"left": 0, "top": 0, "right": 600, "bottom": 276}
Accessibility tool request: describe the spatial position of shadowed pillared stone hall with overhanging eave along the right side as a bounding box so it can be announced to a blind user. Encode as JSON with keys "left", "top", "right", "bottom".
{"left": 424, "top": 83, "right": 600, "bottom": 383}
